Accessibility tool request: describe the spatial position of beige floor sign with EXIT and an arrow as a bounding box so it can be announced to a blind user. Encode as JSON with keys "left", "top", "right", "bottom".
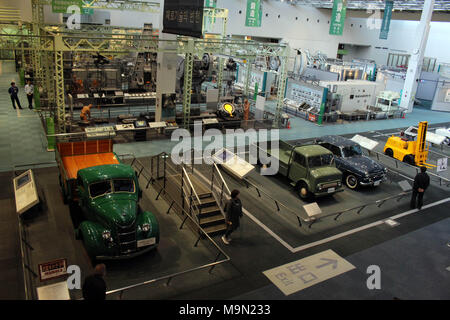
{"left": 263, "top": 250, "right": 355, "bottom": 296}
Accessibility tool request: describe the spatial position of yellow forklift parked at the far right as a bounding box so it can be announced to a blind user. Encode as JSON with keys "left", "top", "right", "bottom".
{"left": 383, "top": 121, "right": 436, "bottom": 168}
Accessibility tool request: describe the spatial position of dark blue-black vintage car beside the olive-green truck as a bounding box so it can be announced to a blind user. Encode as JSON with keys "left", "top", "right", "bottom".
{"left": 316, "top": 136, "right": 387, "bottom": 189}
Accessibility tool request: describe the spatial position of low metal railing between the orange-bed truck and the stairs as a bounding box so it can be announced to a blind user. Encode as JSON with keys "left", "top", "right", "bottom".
{"left": 106, "top": 152, "right": 231, "bottom": 299}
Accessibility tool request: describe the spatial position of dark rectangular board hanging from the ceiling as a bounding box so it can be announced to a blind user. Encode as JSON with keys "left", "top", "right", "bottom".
{"left": 162, "top": 0, "right": 204, "bottom": 38}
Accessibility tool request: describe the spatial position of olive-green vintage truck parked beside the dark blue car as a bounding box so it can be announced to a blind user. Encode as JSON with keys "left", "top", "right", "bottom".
{"left": 267, "top": 141, "right": 343, "bottom": 200}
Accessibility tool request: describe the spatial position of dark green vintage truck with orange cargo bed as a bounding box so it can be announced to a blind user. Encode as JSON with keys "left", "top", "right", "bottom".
{"left": 56, "top": 140, "right": 159, "bottom": 260}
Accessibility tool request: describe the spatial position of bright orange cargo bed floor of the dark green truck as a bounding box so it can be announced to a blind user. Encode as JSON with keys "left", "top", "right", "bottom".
{"left": 62, "top": 152, "right": 119, "bottom": 179}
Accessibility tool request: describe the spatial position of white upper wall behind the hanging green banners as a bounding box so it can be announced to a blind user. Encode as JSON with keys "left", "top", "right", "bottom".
{"left": 214, "top": 0, "right": 450, "bottom": 64}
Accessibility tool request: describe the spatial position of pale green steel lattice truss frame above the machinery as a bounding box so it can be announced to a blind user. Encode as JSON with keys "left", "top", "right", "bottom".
{"left": 0, "top": 8, "right": 289, "bottom": 132}
